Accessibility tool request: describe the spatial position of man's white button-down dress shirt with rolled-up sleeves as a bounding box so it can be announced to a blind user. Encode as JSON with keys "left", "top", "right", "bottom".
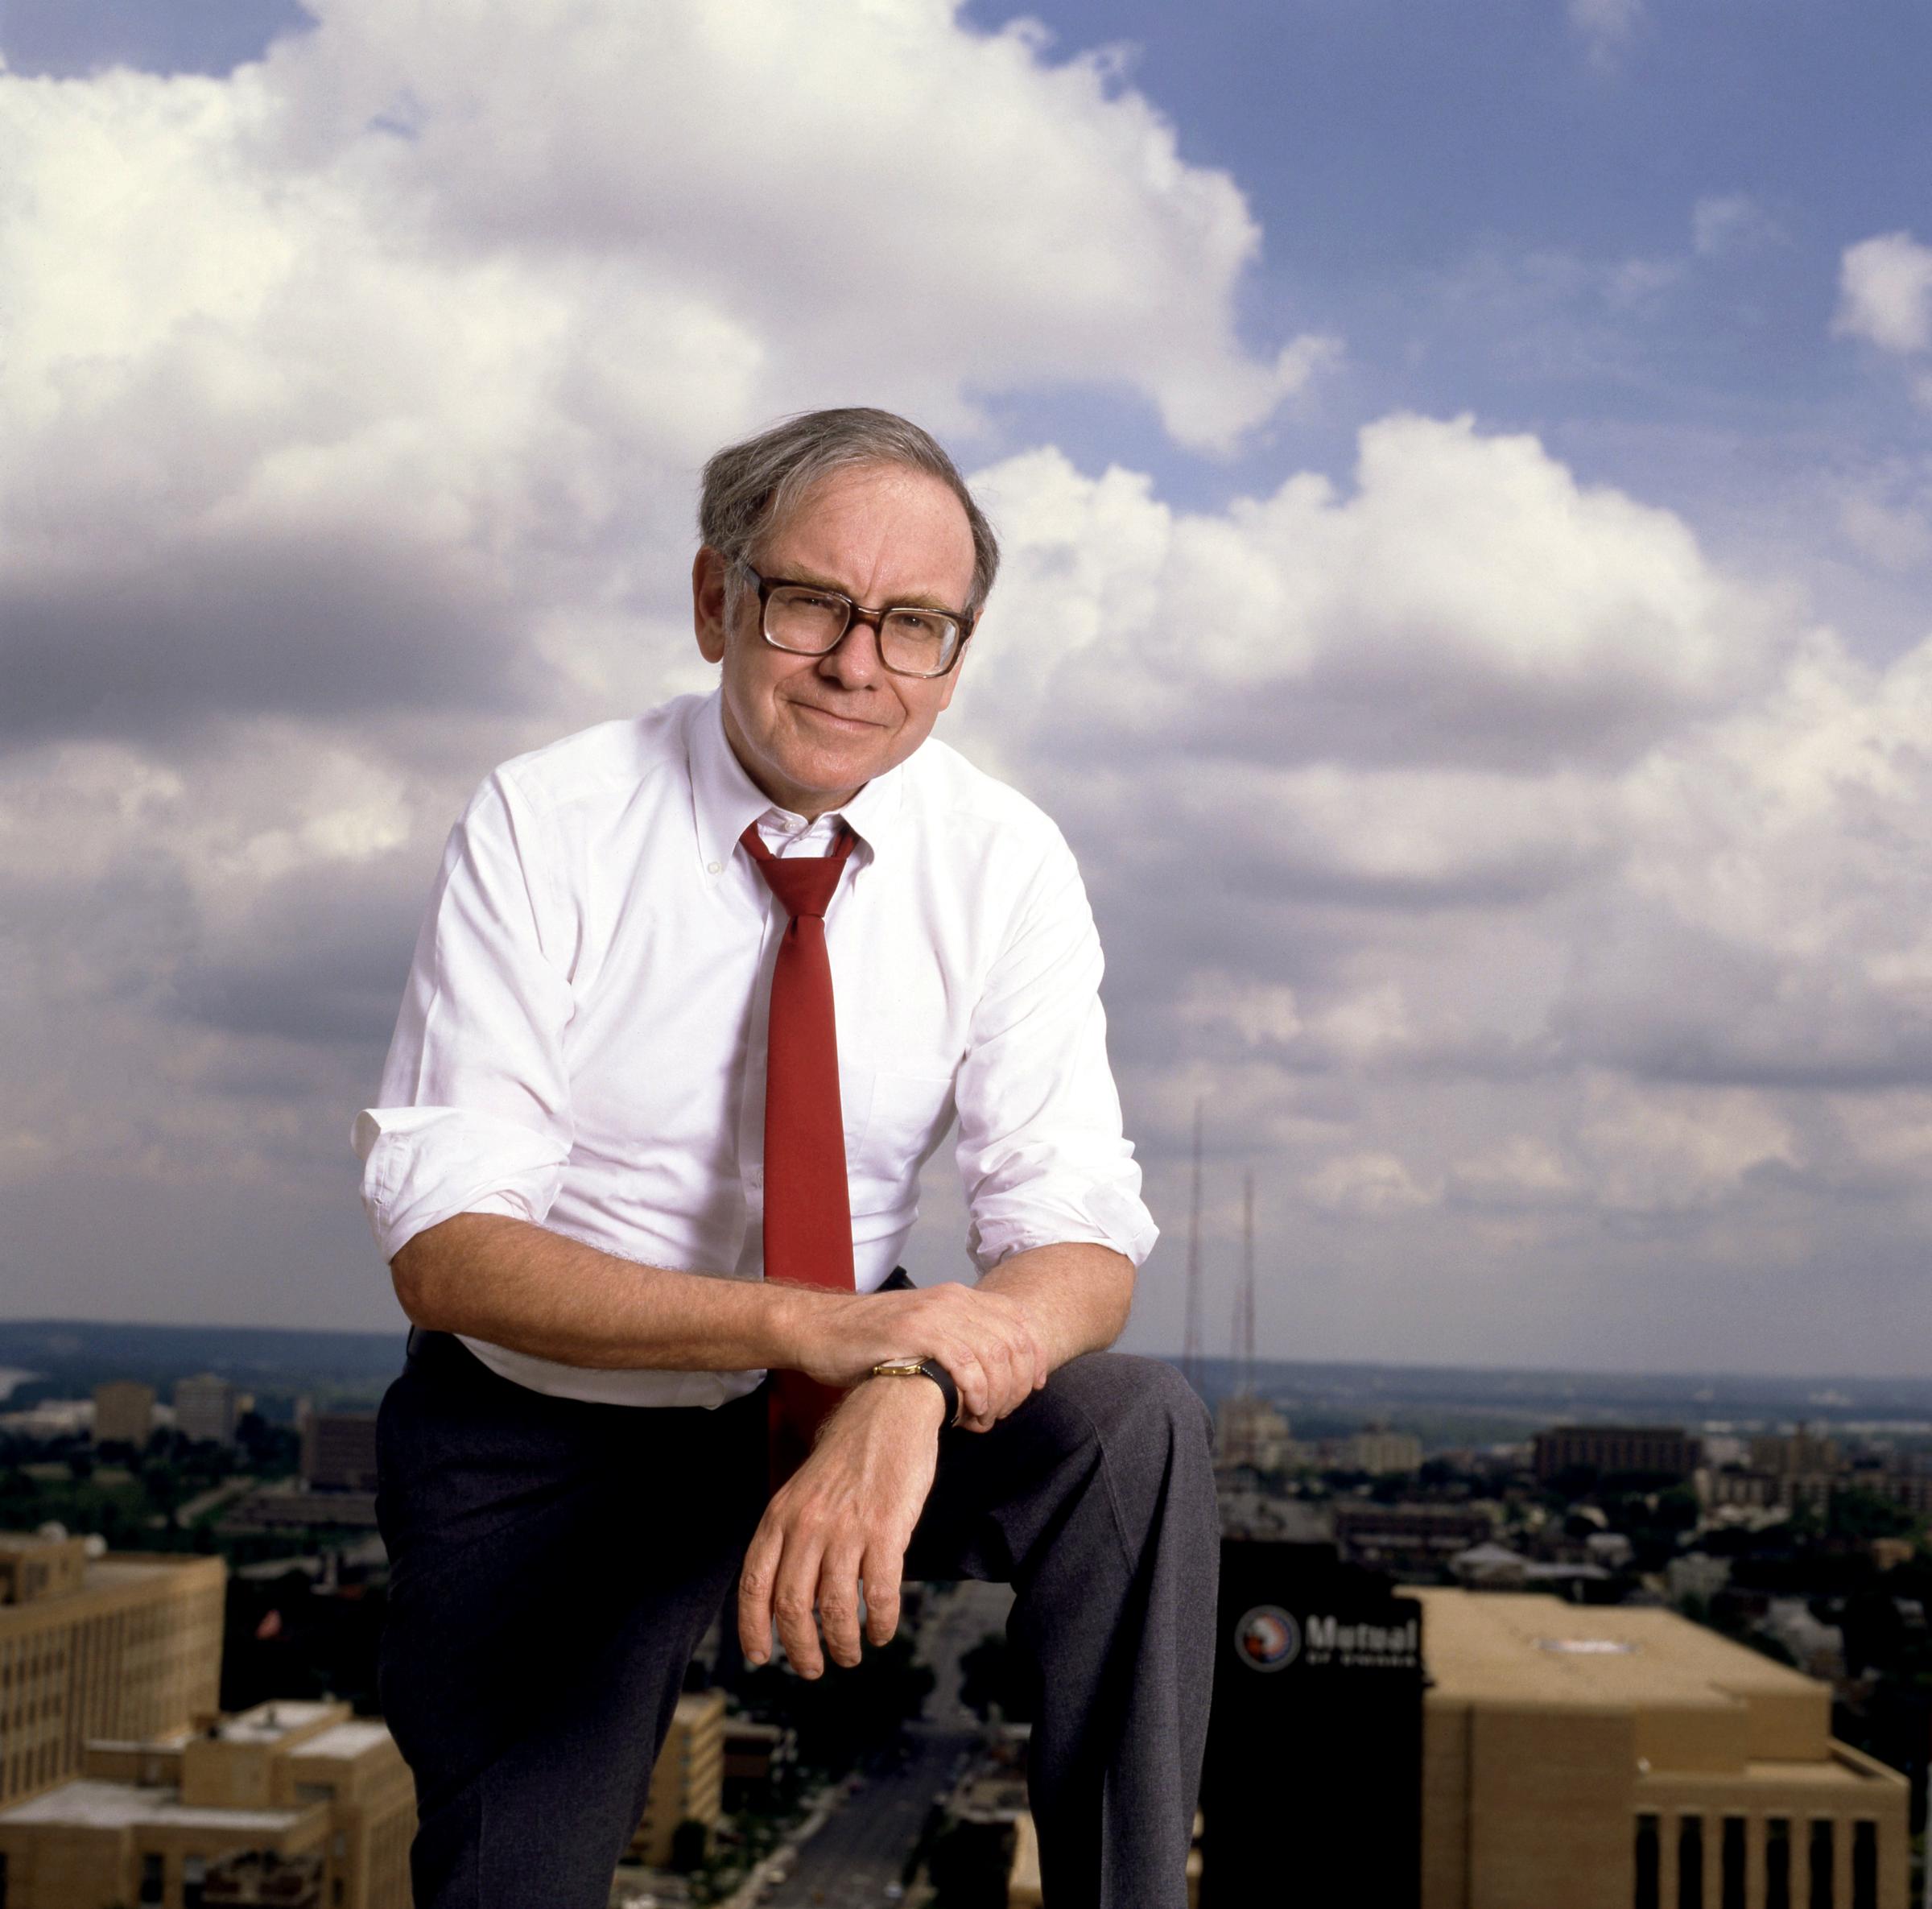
{"left": 353, "top": 694, "right": 1155, "bottom": 1405}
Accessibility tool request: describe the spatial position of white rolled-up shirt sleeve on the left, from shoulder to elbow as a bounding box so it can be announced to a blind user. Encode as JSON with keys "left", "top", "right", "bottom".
{"left": 353, "top": 771, "right": 572, "bottom": 1260}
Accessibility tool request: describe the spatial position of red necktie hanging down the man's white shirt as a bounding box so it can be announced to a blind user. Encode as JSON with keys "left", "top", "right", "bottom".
{"left": 738, "top": 821, "right": 854, "bottom": 1490}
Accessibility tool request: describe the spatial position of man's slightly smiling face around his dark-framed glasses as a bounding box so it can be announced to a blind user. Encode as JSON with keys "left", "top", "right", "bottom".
{"left": 691, "top": 464, "right": 974, "bottom": 816}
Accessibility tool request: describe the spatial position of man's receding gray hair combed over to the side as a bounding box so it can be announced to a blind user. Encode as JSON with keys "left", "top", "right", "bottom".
{"left": 697, "top": 406, "right": 999, "bottom": 617}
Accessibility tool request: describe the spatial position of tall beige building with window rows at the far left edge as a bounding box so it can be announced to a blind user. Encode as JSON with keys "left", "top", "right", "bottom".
{"left": 0, "top": 1532, "right": 228, "bottom": 1800}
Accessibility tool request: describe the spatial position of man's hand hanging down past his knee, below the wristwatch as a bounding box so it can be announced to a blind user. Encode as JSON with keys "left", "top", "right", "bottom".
{"left": 738, "top": 1378, "right": 945, "bottom": 1677}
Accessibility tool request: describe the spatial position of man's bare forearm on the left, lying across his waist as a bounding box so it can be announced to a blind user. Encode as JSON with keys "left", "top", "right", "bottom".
{"left": 390, "top": 1213, "right": 823, "bottom": 1372}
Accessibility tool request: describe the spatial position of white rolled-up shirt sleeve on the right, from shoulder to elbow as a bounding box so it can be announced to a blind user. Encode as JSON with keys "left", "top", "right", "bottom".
{"left": 955, "top": 831, "right": 1158, "bottom": 1271}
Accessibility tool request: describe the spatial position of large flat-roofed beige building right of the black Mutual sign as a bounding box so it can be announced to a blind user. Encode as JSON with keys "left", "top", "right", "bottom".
{"left": 1409, "top": 1589, "right": 1909, "bottom": 1909}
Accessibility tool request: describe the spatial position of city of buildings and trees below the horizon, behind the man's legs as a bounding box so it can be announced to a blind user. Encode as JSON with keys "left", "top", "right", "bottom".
{"left": 0, "top": 1321, "right": 1932, "bottom": 1909}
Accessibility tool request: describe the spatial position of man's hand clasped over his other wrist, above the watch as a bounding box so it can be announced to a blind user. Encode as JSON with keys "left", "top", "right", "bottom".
{"left": 796, "top": 1281, "right": 1051, "bottom": 1432}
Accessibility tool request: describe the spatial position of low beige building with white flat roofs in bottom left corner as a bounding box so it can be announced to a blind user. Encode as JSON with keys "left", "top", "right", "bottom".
{"left": 0, "top": 1702, "right": 415, "bottom": 1909}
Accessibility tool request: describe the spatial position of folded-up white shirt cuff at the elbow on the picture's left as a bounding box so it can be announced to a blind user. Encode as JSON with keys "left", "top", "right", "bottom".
{"left": 352, "top": 1107, "right": 570, "bottom": 1260}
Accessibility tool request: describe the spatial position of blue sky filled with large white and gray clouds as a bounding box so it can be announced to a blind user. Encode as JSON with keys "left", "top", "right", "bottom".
{"left": 0, "top": 0, "right": 1932, "bottom": 1374}
